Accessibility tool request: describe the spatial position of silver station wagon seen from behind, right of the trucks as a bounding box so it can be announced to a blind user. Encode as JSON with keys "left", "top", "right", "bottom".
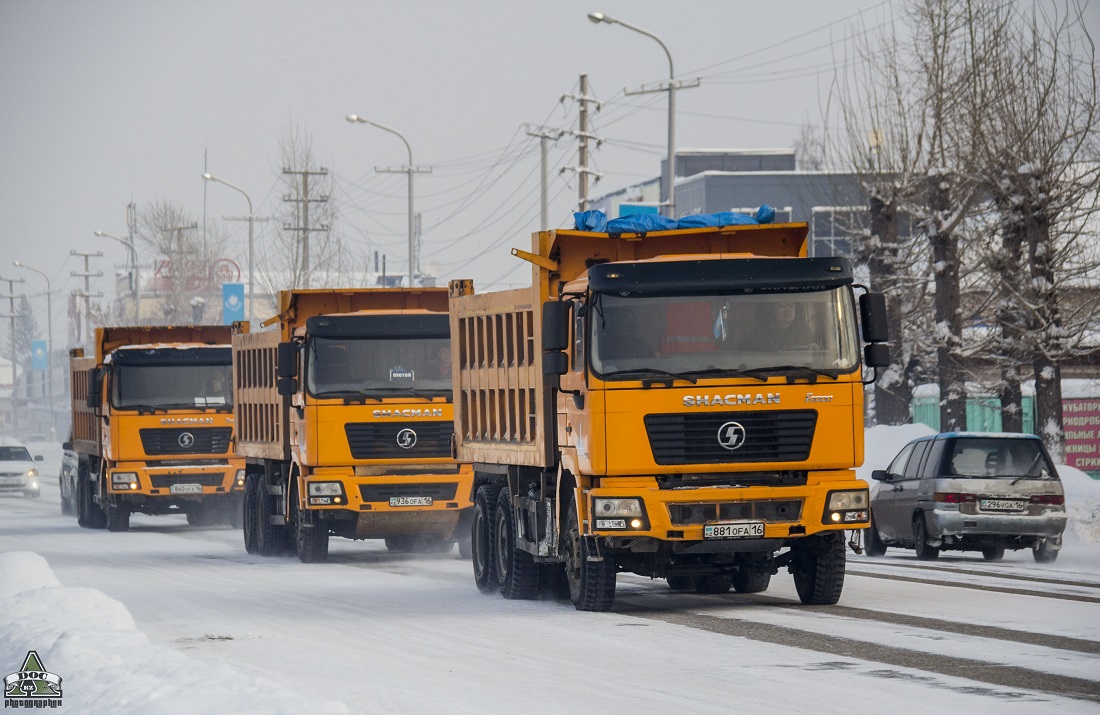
{"left": 866, "top": 432, "right": 1066, "bottom": 563}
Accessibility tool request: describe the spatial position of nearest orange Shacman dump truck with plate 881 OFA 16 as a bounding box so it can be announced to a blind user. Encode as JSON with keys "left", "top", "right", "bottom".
{"left": 451, "top": 214, "right": 889, "bottom": 611}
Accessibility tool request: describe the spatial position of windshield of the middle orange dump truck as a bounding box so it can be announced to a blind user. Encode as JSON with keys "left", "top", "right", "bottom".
{"left": 306, "top": 337, "right": 451, "bottom": 398}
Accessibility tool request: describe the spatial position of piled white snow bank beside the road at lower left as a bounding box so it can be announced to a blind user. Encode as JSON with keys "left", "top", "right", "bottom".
{"left": 0, "top": 552, "right": 350, "bottom": 715}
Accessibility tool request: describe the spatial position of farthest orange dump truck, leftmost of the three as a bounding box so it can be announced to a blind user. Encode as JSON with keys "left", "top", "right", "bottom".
{"left": 69, "top": 326, "right": 244, "bottom": 531}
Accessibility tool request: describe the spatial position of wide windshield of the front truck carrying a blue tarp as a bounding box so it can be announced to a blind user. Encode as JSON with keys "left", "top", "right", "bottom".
{"left": 589, "top": 286, "right": 859, "bottom": 380}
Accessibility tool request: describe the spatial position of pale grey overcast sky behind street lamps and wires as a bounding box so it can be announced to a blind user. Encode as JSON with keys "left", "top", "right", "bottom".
{"left": 0, "top": 0, "right": 1100, "bottom": 342}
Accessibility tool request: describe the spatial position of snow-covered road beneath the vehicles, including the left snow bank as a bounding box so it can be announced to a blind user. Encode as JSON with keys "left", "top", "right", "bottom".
{"left": 0, "top": 465, "right": 1100, "bottom": 715}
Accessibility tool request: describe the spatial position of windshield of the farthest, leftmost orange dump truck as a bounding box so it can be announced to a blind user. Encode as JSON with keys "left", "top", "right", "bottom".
{"left": 111, "top": 364, "right": 233, "bottom": 409}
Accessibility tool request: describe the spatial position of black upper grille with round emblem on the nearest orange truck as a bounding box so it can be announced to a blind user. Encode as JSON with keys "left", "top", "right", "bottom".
{"left": 646, "top": 409, "right": 817, "bottom": 464}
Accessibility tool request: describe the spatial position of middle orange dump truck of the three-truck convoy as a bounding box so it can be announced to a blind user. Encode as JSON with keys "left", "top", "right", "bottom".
{"left": 233, "top": 282, "right": 473, "bottom": 563}
